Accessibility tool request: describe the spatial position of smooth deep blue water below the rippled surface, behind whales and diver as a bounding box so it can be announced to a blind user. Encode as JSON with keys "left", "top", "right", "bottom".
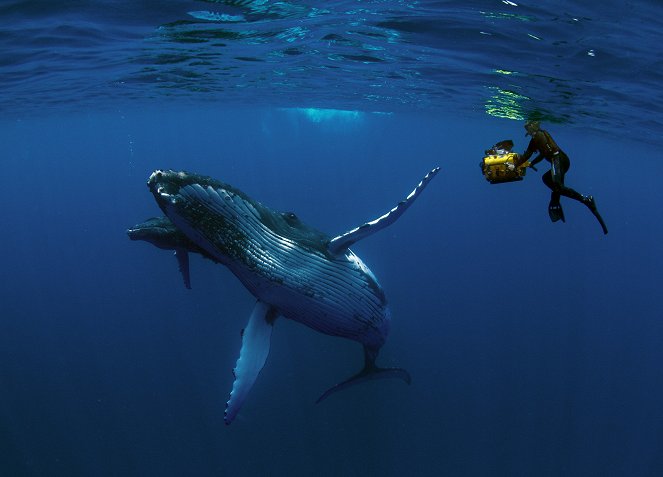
{"left": 0, "top": 107, "right": 663, "bottom": 476}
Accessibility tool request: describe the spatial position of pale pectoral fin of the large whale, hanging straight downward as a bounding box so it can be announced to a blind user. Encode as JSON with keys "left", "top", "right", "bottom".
{"left": 223, "top": 301, "right": 276, "bottom": 424}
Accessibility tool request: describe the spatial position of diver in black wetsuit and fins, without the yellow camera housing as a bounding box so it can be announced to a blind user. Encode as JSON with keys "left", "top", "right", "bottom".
{"left": 516, "top": 121, "right": 608, "bottom": 234}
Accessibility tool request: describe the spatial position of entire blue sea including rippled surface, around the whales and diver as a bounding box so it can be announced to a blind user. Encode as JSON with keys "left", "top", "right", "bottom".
{"left": 0, "top": 0, "right": 663, "bottom": 476}
